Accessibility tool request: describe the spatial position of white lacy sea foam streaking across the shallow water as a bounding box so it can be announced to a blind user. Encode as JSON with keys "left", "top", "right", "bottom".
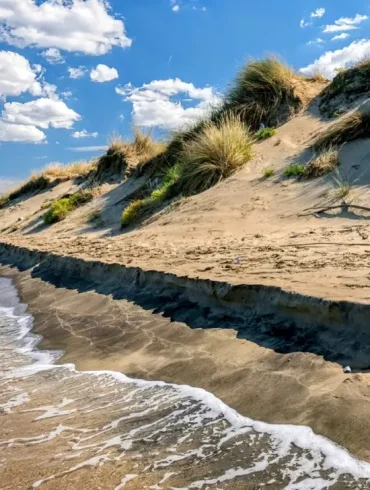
{"left": 0, "top": 281, "right": 370, "bottom": 490}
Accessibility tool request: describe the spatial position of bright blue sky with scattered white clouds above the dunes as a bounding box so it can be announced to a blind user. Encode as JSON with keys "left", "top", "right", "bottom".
{"left": 0, "top": 0, "right": 370, "bottom": 182}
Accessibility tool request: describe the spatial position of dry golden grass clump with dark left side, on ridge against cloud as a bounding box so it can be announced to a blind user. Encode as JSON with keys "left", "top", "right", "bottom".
{"left": 96, "top": 127, "right": 166, "bottom": 179}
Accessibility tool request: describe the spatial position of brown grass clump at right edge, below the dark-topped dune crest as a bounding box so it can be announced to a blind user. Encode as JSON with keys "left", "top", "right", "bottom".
{"left": 314, "top": 110, "right": 370, "bottom": 149}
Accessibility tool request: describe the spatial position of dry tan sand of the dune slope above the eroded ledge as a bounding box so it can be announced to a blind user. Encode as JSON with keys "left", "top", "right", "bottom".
{"left": 0, "top": 101, "right": 370, "bottom": 302}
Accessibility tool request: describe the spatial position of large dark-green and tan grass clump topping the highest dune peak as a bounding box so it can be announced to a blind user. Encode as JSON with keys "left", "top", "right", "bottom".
{"left": 226, "top": 56, "right": 302, "bottom": 130}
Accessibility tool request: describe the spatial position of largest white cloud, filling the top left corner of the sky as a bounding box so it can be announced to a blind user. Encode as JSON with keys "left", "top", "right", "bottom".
{"left": 0, "top": 0, "right": 132, "bottom": 55}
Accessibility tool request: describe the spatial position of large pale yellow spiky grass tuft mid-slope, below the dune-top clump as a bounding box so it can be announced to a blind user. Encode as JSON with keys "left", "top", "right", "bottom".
{"left": 177, "top": 114, "right": 253, "bottom": 195}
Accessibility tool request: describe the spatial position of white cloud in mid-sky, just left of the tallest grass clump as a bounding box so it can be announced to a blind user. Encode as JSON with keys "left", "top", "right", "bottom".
{"left": 116, "top": 78, "right": 220, "bottom": 130}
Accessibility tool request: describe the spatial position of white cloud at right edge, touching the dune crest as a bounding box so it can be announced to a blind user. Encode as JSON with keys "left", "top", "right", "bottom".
{"left": 300, "top": 39, "right": 370, "bottom": 78}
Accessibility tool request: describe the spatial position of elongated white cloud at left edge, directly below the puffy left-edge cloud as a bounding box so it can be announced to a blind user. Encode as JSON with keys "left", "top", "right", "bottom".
{"left": 1, "top": 98, "right": 81, "bottom": 129}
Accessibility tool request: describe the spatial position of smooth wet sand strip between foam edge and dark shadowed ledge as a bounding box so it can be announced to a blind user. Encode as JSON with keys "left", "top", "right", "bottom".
{"left": 0, "top": 267, "right": 370, "bottom": 466}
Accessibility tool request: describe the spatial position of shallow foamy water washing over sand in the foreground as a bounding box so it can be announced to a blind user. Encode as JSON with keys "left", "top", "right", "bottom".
{"left": 0, "top": 278, "right": 370, "bottom": 490}
